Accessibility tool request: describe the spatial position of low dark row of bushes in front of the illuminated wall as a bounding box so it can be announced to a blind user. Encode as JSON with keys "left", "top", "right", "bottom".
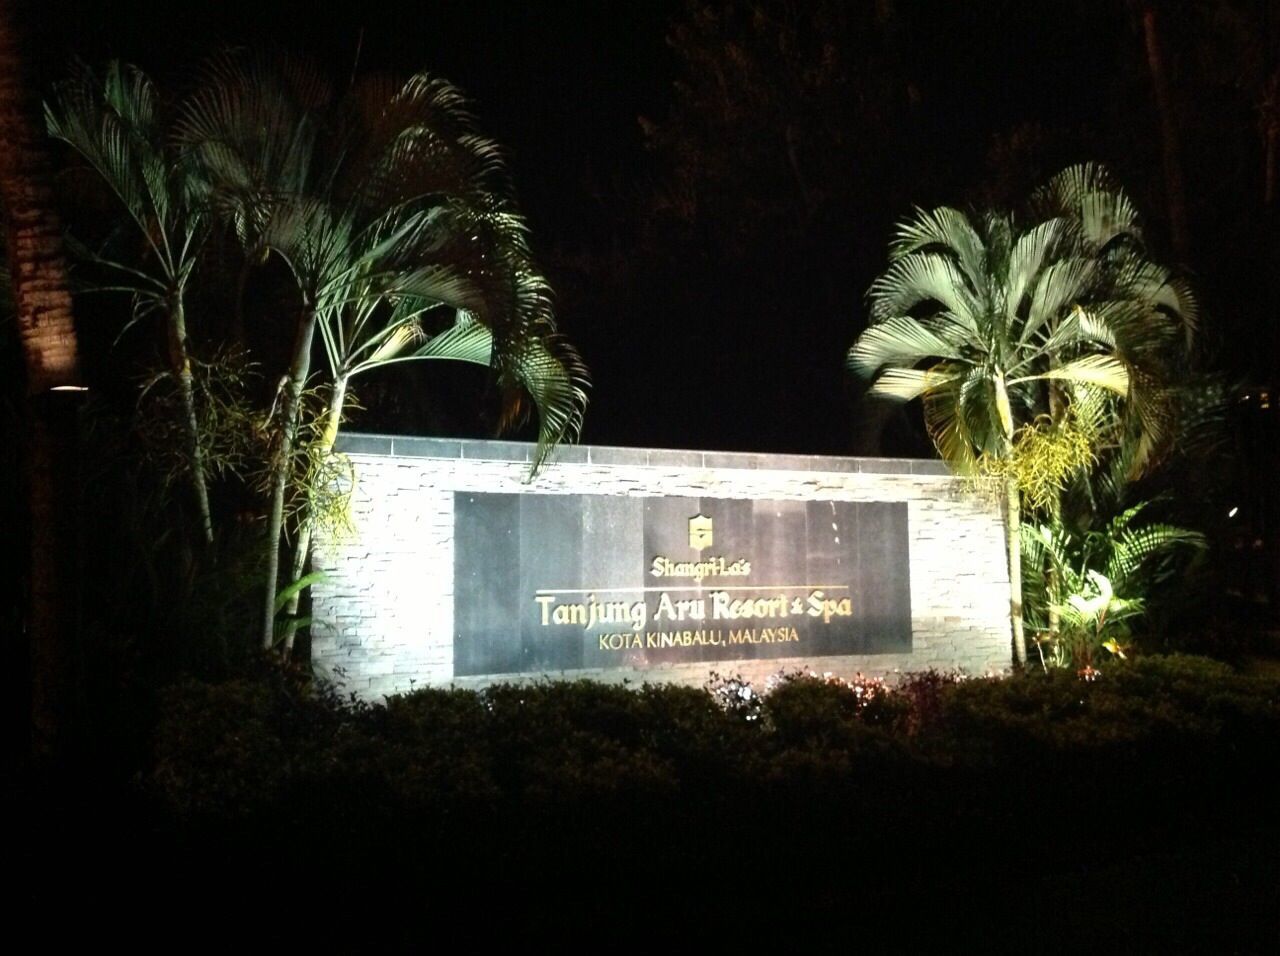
{"left": 152, "top": 657, "right": 1280, "bottom": 845}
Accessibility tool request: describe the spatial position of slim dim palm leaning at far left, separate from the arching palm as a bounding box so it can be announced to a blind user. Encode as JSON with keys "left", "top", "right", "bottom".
{"left": 45, "top": 61, "right": 214, "bottom": 544}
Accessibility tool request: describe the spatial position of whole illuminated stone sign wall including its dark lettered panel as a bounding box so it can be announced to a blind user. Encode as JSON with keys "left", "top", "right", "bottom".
{"left": 312, "top": 435, "right": 1010, "bottom": 697}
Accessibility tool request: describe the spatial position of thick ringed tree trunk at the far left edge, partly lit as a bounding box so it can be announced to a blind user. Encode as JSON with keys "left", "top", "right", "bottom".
{"left": 0, "top": 0, "right": 79, "bottom": 763}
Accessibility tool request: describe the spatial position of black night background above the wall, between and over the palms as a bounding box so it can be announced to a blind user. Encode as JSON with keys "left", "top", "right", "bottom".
{"left": 27, "top": 0, "right": 1276, "bottom": 456}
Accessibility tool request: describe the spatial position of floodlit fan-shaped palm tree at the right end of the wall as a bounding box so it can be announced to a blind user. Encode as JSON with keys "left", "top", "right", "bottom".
{"left": 847, "top": 165, "right": 1196, "bottom": 664}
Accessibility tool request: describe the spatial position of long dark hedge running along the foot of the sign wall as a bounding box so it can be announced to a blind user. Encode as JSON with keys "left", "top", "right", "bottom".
{"left": 151, "top": 657, "right": 1280, "bottom": 872}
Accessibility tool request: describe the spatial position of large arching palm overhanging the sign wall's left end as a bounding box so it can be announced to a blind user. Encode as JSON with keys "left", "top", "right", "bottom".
{"left": 180, "top": 54, "right": 584, "bottom": 645}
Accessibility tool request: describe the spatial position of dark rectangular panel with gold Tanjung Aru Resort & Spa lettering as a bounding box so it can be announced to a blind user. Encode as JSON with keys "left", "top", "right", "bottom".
{"left": 453, "top": 491, "right": 911, "bottom": 676}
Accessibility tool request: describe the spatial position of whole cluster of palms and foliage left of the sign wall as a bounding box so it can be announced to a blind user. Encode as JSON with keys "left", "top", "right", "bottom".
{"left": 45, "top": 50, "right": 588, "bottom": 665}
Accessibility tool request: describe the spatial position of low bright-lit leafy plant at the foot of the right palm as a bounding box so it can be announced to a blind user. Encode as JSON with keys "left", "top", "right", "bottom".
{"left": 1021, "top": 502, "right": 1204, "bottom": 667}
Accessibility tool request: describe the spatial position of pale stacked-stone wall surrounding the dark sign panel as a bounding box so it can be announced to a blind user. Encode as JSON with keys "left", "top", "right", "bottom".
{"left": 311, "top": 434, "right": 1010, "bottom": 699}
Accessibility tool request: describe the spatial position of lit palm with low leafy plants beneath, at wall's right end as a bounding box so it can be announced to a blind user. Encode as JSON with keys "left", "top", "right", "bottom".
{"left": 849, "top": 165, "right": 1204, "bottom": 667}
